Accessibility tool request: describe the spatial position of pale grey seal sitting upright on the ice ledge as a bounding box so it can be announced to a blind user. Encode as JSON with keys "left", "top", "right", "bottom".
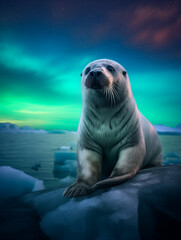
{"left": 64, "top": 59, "right": 162, "bottom": 197}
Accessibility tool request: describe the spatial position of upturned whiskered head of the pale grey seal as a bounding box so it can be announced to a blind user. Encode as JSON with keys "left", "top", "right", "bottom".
{"left": 81, "top": 59, "right": 130, "bottom": 105}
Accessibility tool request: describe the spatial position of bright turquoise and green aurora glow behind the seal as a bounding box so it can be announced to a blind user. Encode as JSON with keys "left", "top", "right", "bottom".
{"left": 0, "top": 44, "right": 181, "bottom": 130}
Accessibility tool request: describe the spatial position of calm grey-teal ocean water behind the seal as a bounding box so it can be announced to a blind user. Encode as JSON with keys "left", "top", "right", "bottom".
{"left": 0, "top": 133, "right": 181, "bottom": 188}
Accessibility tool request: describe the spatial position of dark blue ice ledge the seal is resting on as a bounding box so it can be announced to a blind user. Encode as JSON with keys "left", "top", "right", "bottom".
{"left": 0, "top": 164, "right": 181, "bottom": 240}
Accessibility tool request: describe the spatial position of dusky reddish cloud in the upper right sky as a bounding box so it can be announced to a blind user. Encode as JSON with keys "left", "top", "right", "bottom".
{"left": 128, "top": 6, "right": 181, "bottom": 48}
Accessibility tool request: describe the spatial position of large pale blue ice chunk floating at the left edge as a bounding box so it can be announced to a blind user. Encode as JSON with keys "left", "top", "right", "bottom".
{"left": 0, "top": 166, "right": 45, "bottom": 200}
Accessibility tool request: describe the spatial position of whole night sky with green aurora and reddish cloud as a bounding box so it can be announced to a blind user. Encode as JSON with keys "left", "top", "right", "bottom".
{"left": 0, "top": 0, "right": 181, "bottom": 130}
